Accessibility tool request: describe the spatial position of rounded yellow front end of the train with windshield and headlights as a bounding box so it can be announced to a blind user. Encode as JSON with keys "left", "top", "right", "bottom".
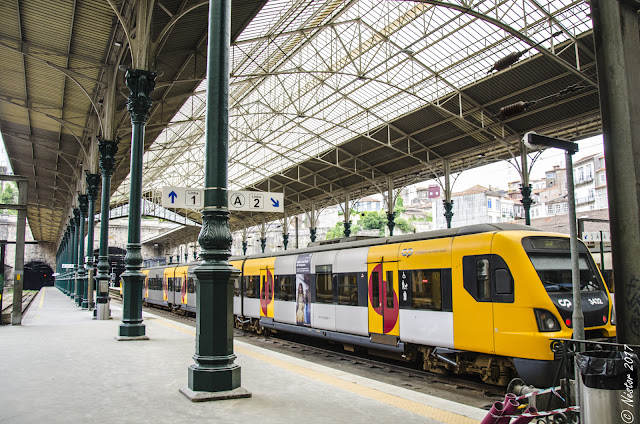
{"left": 490, "top": 231, "right": 616, "bottom": 387}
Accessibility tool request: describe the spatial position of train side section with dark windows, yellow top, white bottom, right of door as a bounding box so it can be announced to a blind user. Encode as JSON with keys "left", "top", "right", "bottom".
{"left": 398, "top": 238, "right": 454, "bottom": 348}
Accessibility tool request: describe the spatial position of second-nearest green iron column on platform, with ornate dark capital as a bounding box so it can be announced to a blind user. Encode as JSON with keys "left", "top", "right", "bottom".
{"left": 117, "top": 69, "right": 157, "bottom": 340}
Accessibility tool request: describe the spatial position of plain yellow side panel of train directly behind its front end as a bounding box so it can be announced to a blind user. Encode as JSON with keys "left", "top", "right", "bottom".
{"left": 451, "top": 233, "right": 495, "bottom": 353}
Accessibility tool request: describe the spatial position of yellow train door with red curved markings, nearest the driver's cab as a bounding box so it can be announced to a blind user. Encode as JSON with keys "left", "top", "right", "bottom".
{"left": 367, "top": 245, "right": 400, "bottom": 345}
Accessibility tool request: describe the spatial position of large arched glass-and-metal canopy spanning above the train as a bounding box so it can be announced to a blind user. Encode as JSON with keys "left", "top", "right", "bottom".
{"left": 0, "top": 0, "right": 601, "bottom": 242}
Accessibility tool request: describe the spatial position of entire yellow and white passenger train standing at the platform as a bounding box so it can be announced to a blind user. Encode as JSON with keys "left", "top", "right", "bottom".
{"left": 143, "top": 224, "right": 616, "bottom": 387}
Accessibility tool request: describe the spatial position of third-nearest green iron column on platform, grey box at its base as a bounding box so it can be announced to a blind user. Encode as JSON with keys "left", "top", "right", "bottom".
{"left": 94, "top": 139, "right": 118, "bottom": 320}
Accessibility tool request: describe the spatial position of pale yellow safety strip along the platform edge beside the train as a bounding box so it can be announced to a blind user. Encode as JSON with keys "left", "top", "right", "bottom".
{"left": 155, "top": 320, "right": 478, "bottom": 424}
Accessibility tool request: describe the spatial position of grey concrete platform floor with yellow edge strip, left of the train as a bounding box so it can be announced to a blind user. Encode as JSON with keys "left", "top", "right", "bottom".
{"left": 0, "top": 287, "right": 486, "bottom": 424}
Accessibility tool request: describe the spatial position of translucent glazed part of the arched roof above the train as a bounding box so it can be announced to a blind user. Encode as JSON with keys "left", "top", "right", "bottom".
{"left": 113, "top": 0, "right": 591, "bottom": 202}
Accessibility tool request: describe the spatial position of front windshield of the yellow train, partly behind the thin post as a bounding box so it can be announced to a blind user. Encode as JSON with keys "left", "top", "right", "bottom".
{"left": 525, "top": 239, "right": 604, "bottom": 292}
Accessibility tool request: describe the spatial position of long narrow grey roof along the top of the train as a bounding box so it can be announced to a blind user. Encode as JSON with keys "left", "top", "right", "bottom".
{"left": 229, "top": 224, "right": 540, "bottom": 261}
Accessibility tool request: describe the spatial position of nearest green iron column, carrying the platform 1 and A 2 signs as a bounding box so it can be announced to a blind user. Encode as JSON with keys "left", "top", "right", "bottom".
{"left": 180, "top": 0, "right": 251, "bottom": 401}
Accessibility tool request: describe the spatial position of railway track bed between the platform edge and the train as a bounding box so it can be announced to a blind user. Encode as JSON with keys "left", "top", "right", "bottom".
{"left": 120, "top": 299, "right": 504, "bottom": 409}
